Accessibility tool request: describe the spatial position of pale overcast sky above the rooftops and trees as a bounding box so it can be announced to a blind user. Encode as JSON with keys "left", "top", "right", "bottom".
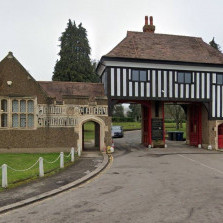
{"left": 0, "top": 0, "right": 223, "bottom": 80}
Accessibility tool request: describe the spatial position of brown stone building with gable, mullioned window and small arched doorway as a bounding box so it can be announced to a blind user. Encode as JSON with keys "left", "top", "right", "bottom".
{"left": 0, "top": 52, "right": 111, "bottom": 152}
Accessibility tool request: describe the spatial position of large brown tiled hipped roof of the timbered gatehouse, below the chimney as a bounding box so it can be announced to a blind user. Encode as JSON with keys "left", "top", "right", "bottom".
{"left": 104, "top": 31, "right": 223, "bottom": 65}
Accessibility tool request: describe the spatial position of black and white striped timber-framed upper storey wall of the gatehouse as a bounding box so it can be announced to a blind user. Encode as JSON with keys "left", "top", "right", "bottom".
{"left": 98, "top": 57, "right": 223, "bottom": 119}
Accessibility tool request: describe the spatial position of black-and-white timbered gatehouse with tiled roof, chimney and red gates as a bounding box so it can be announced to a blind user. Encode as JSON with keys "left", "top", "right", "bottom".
{"left": 97, "top": 17, "right": 223, "bottom": 149}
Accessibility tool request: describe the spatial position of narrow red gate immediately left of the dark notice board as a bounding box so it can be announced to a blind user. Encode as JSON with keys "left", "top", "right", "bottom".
{"left": 142, "top": 103, "right": 152, "bottom": 146}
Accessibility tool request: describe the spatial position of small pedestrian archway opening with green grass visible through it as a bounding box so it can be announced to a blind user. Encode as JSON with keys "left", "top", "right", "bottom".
{"left": 82, "top": 121, "right": 100, "bottom": 151}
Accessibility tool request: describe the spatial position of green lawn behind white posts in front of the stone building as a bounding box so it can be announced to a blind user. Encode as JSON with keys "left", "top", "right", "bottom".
{"left": 0, "top": 153, "right": 74, "bottom": 191}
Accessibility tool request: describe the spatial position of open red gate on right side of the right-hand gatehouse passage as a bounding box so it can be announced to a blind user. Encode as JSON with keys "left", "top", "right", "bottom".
{"left": 190, "top": 104, "right": 202, "bottom": 146}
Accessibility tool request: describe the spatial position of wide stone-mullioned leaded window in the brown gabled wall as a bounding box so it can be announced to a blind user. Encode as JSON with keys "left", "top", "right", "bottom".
{"left": 0, "top": 99, "right": 34, "bottom": 128}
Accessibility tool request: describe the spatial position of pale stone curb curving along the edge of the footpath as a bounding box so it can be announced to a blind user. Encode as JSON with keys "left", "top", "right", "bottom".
{"left": 0, "top": 153, "right": 110, "bottom": 214}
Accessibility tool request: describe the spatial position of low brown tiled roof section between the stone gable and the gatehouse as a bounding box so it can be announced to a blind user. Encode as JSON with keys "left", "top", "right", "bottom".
{"left": 38, "top": 81, "right": 105, "bottom": 101}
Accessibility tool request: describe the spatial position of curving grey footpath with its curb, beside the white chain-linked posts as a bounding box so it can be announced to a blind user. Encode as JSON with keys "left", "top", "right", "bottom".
{"left": 0, "top": 152, "right": 109, "bottom": 213}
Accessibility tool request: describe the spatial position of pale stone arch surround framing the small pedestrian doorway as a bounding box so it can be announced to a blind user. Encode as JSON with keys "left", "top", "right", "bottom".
{"left": 75, "top": 115, "right": 108, "bottom": 151}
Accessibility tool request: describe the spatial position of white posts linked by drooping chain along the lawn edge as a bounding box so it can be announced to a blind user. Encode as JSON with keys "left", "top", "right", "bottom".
{"left": 0, "top": 146, "right": 82, "bottom": 188}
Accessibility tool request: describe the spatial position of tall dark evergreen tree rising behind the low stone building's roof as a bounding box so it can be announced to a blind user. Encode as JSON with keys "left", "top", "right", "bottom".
{"left": 52, "top": 19, "right": 99, "bottom": 82}
